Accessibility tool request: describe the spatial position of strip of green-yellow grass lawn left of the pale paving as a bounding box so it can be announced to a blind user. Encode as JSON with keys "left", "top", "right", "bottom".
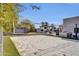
{"left": 3, "top": 36, "right": 20, "bottom": 56}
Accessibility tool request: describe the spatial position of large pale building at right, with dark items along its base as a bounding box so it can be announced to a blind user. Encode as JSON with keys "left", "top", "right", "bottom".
{"left": 60, "top": 16, "right": 79, "bottom": 38}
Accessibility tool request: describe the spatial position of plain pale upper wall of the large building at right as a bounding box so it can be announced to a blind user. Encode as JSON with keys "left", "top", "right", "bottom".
{"left": 63, "top": 17, "right": 79, "bottom": 33}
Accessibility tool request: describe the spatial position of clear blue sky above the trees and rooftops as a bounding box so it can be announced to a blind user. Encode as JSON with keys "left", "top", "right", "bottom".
{"left": 20, "top": 3, "right": 79, "bottom": 25}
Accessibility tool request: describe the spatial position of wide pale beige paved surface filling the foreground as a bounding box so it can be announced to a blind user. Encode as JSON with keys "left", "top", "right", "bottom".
{"left": 11, "top": 35, "right": 79, "bottom": 56}
